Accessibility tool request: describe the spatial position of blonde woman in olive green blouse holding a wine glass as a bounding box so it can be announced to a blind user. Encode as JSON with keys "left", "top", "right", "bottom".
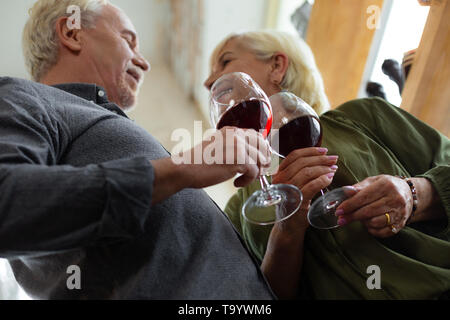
{"left": 205, "top": 31, "right": 450, "bottom": 299}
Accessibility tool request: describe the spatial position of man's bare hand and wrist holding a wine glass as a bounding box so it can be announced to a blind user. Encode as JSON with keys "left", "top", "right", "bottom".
{"left": 151, "top": 127, "right": 270, "bottom": 204}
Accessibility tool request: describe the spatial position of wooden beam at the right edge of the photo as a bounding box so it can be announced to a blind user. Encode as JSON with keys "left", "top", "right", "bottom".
{"left": 401, "top": 0, "right": 450, "bottom": 137}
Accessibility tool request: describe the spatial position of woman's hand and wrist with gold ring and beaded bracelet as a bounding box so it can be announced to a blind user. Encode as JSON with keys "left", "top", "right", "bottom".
{"left": 336, "top": 175, "right": 446, "bottom": 238}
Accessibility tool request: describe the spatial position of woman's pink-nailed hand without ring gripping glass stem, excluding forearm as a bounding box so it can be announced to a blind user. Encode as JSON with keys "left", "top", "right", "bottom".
{"left": 272, "top": 148, "right": 338, "bottom": 231}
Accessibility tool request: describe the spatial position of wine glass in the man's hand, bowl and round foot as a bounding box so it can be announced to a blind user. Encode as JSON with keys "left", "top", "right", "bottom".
{"left": 210, "top": 72, "right": 303, "bottom": 225}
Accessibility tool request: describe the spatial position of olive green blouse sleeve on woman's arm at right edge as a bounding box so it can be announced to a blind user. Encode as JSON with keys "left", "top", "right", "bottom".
{"left": 339, "top": 98, "right": 450, "bottom": 240}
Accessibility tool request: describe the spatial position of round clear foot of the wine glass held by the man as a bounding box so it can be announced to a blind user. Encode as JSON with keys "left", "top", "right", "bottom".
{"left": 242, "top": 184, "right": 303, "bottom": 225}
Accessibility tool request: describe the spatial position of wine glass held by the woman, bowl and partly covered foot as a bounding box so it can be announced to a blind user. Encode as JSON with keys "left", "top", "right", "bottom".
{"left": 270, "top": 91, "right": 352, "bottom": 229}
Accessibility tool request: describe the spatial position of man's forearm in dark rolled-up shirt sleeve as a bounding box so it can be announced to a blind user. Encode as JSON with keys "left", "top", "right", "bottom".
{"left": 0, "top": 158, "right": 153, "bottom": 258}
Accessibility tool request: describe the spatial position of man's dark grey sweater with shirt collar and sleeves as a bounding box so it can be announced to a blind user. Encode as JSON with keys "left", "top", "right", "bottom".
{"left": 0, "top": 77, "right": 274, "bottom": 299}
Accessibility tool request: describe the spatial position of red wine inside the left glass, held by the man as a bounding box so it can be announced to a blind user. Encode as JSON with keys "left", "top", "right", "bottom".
{"left": 217, "top": 100, "right": 272, "bottom": 137}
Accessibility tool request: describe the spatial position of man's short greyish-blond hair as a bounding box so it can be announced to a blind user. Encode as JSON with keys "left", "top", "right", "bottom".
{"left": 22, "top": 0, "right": 108, "bottom": 81}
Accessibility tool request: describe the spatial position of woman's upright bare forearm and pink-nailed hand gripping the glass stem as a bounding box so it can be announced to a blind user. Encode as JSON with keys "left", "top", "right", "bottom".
{"left": 261, "top": 148, "right": 337, "bottom": 299}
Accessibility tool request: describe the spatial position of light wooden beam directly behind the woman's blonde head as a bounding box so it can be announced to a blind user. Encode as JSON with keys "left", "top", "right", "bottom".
{"left": 306, "top": 0, "right": 383, "bottom": 108}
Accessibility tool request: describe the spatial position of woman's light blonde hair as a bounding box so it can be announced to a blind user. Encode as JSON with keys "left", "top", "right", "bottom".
{"left": 211, "top": 30, "right": 330, "bottom": 114}
